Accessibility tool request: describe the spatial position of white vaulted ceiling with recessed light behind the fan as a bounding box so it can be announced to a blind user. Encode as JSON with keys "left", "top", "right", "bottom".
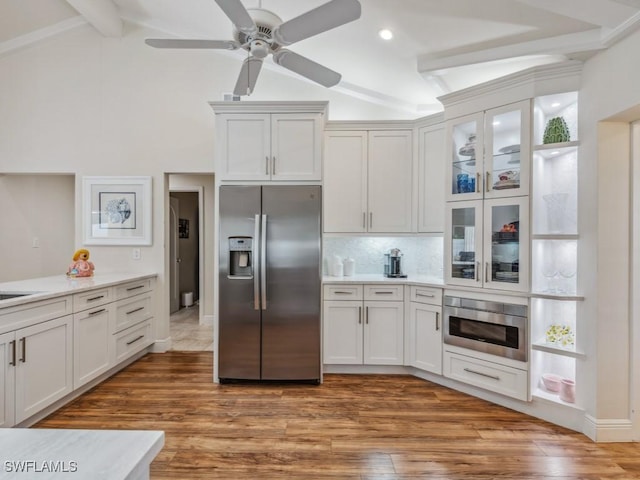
{"left": 0, "top": 0, "right": 640, "bottom": 116}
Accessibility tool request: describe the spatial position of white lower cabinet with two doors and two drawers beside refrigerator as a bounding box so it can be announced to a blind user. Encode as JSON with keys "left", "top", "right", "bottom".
{"left": 323, "top": 285, "right": 404, "bottom": 365}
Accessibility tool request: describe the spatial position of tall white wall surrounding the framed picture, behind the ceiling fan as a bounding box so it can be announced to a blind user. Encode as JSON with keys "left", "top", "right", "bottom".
{"left": 0, "top": 21, "right": 405, "bottom": 340}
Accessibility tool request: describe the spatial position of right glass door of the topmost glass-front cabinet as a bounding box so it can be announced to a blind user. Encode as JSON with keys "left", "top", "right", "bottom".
{"left": 483, "top": 100, "right": 531, "bottom": 198}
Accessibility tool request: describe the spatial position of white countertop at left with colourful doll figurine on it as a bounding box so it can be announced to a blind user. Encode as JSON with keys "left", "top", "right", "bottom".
{"left": 0, "top": 272, "right": 156, "bottom": 308}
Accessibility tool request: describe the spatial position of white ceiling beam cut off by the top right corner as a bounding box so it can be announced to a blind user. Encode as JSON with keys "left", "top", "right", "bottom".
{"left": 516, "top": 0, "right": 638, "bottom": 28}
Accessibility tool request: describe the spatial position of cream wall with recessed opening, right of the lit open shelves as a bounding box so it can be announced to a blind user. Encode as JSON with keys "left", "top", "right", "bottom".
{"left": 579, "top": 27, "right": 640, "bottom": 439}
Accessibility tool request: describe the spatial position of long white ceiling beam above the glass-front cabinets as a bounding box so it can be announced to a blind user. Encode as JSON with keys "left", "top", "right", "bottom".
{"left": 418, "top": 28, "right": 605, "bottom": 75}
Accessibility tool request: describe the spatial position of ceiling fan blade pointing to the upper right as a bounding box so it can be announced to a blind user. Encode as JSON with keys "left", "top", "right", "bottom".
{"left": 273, "top": 0, "right": 361, "bottom": 45}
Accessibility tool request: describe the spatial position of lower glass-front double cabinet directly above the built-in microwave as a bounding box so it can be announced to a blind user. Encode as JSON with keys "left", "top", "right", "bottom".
{"left": 445, "top": 197, "right": 529, "bottom": 291}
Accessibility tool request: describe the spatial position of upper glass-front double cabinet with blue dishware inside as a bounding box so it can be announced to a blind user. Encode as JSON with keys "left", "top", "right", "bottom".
{"left": 447, "top": 100, "right": 531, "bottom": 201}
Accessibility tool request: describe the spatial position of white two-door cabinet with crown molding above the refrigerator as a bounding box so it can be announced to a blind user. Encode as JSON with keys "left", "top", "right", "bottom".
{"left": 211, "top": 102, "right": 326, "bottom": 182}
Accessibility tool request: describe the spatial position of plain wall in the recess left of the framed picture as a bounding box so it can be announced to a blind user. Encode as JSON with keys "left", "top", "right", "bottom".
{"left": 0, "top": 175, "right": 75, "bottom": 282}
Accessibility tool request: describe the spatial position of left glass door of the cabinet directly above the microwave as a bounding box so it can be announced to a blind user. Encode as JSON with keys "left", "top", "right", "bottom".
{"left": 444, "top": 200, "right": 483, "bottom": 287}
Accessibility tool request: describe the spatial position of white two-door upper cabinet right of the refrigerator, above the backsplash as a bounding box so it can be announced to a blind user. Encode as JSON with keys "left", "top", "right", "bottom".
{"left": 324, "top": 130, "right": 413, "bottom": 233}
